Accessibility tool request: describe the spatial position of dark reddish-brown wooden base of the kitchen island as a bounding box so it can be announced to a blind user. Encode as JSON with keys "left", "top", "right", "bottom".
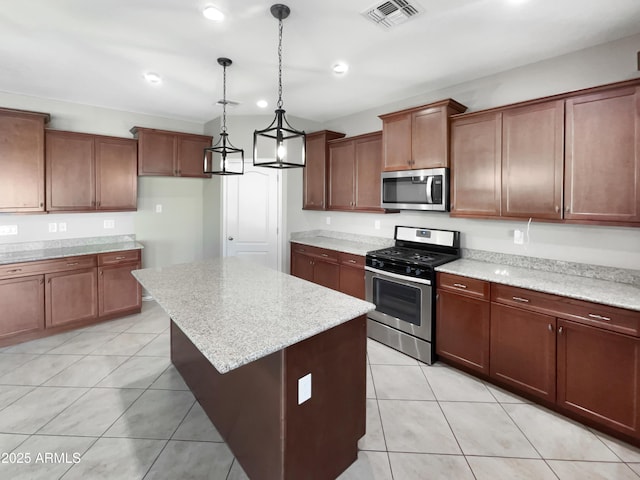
{"left": 171, "top": 316, "right": 366, "bottom": 480}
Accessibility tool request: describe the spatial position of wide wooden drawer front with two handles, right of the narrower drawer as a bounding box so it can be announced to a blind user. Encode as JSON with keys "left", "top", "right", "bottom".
{"left": 491, "top": 284, "right": 640, "bottom": 337}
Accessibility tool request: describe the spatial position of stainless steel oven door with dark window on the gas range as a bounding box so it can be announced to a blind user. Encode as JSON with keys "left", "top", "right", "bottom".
{"left": 365, "top": 267, "right": 432, "bottom": 342}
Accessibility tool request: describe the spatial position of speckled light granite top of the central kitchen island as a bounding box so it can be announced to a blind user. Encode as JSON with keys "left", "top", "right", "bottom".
{"left": 133, "top": 257, "right": 375, "bottom": 373}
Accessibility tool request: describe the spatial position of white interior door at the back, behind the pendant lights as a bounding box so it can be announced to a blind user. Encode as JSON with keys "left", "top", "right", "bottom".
{"left": 222, "top": 163, "right": 281, "bottom": 270}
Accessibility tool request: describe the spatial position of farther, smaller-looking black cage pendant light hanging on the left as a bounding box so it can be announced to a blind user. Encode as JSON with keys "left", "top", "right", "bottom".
{"left": 204, "top": 57, "right": 244, "bottom": 175}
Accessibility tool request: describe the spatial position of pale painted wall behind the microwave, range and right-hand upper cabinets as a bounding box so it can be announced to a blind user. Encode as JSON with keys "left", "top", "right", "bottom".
{"left": 288, "top": 35, "right": 640, "bottom": 269}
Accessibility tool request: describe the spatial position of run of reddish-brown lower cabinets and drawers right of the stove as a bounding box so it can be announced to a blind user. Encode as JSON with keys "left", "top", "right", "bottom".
{"left": 436, "top": 273, "right": 640, "bottom": 445}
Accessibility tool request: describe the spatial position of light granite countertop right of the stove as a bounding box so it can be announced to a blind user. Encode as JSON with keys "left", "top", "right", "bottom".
{"left": 436, "top": 258, "right": 640, "bottom": 311}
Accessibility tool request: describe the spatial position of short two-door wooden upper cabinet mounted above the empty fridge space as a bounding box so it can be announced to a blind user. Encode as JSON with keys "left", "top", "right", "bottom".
{"left": 131, "top": 127, "right": 213, "bottom": 178}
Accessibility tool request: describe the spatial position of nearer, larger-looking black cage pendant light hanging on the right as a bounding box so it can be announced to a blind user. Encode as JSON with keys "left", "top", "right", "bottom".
{"left": 253, "top": 3, "right": 306, "bottom": 168}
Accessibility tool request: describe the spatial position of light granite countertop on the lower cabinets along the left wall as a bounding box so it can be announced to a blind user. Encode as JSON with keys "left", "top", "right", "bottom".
{"left": 0, "top": 240, "right": 144, "bottom": 265}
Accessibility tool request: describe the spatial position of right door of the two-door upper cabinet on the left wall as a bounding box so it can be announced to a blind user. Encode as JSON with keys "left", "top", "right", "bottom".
{"left": 95, "top": 137, "right": 138, "bottom": 210}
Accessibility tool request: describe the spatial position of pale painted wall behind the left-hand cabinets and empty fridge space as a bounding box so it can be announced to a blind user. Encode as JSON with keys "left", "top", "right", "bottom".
{"left": 0, "top": 92, "right": 205, "bottom": 267}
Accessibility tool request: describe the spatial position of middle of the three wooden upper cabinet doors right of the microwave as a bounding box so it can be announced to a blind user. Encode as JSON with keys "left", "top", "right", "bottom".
{"left": 502, "top": 100, "right": 564, "bottom": 219}
